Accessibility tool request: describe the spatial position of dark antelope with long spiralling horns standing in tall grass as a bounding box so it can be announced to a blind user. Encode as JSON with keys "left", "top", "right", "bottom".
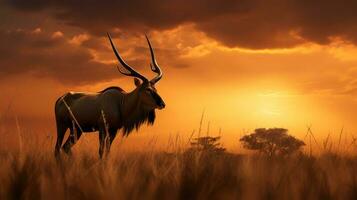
{"left": 55, "top": 33, "right": 165, "bottom": 158}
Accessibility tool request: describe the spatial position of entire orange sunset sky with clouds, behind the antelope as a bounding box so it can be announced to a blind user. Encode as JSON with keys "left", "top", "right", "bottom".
{"left": 0, "top": 0, "right": 357, "bottom": 149}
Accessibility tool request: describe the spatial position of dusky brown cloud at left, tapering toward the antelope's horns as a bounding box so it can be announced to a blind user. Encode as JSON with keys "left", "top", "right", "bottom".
{"left": 0, "top": 30, "right": 118, "bottom": 84}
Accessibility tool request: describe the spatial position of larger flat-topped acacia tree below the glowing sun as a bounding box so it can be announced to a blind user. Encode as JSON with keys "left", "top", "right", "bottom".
{"left": 240, "top": 128, "right": 305, "bottom": 156}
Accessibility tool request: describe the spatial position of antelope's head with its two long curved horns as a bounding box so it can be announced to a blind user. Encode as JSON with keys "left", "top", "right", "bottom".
{"left": 108, "top": 33, "right": 165, "bottom": 110}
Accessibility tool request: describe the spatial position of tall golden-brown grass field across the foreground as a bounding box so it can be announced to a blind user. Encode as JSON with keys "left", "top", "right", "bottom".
{"left": 0, "top": 123, "right": 357, "bottom": 199}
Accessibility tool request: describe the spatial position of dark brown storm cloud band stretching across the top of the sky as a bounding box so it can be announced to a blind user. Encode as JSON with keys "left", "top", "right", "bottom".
{"left": 8, "top": 0, "right": 357, "bottom": 49}
